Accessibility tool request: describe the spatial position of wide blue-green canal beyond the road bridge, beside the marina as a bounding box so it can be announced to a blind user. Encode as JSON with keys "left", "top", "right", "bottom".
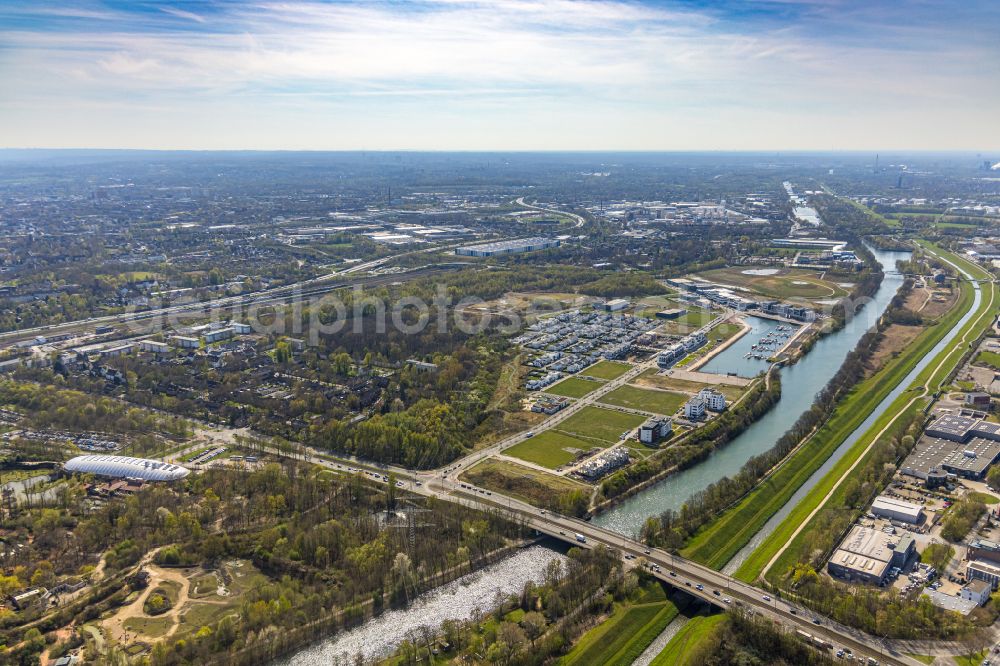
{"left": 593, "top": 250, "right": 909, "bottom": 536}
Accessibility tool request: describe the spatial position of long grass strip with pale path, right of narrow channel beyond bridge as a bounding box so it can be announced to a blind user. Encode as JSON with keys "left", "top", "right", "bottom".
{"left": 736, "top": 262, "right": 994, "bottom": 581}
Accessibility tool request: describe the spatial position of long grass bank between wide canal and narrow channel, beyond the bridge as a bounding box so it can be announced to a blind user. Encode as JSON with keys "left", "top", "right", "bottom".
{"left": 682, "top": 262, "right": 986, "bottom": 567}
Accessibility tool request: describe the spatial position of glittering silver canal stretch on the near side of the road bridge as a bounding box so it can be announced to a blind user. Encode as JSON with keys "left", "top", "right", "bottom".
{"left": 276, "top": 546, "right": 566, "bottom": 666}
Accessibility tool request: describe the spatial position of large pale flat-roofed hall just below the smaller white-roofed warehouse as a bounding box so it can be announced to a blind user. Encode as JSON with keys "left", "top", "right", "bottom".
{"left": 826, "top": 525, "right": 914, "bottom": 585}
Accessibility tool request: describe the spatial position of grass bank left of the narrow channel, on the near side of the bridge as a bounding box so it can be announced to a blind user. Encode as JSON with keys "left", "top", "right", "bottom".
{"left": 559, "top": 601, "right": 677, "bottom": 666}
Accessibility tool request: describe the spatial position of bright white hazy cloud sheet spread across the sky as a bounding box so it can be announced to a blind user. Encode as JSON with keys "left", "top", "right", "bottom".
{"left": 0, "top": 0, "right": 1000, "bottom": 148}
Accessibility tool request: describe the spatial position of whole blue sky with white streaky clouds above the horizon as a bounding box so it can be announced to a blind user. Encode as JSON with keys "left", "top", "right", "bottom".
{"left": 0, "top": 0, "right": 1000, "bottom": 151}
